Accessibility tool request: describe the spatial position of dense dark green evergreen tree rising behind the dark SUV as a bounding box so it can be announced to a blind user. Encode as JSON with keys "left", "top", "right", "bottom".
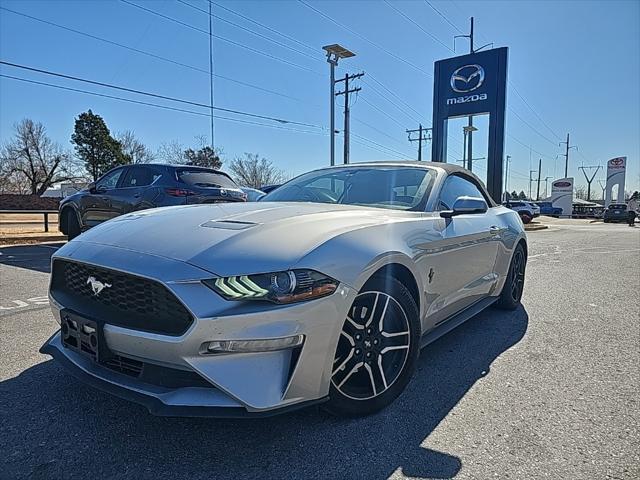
{"left": 71, "top": 110, "right": 131, "bottom": 181}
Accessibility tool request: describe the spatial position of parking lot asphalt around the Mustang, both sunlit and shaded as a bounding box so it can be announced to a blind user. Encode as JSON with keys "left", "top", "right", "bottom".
{"left": 0, "top": 222, "right": 640, "bottom": 480}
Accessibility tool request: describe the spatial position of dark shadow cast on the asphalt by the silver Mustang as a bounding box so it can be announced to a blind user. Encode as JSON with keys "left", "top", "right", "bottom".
{"left": 0, "top": 307, "right": 528, "bottom": 480}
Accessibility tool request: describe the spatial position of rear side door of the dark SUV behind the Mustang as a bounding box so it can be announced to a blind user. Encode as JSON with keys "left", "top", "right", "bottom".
{"left": 111, "top": 165, "right": 160, "bottom": 216}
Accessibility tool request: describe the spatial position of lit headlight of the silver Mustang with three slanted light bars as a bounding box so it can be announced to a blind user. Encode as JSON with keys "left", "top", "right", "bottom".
{"left": 203, "top": 270, "right": 338, "bottom": 303}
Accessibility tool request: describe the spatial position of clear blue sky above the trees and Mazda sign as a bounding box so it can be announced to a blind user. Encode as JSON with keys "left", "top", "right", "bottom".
{"left": 0, "top": 0, "right": 640, "bottom": 196}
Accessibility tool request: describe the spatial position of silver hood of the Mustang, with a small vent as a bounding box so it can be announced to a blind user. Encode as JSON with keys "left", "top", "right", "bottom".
{"left": 69, "top": 202, "right": 415, "bottom": 276}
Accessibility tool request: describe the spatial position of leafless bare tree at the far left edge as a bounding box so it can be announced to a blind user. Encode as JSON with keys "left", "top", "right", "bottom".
{"left": 0, "top": 118, "right": 78, "bottom": 195}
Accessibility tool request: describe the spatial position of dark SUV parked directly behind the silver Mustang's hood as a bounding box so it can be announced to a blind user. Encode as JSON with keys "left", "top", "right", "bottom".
{"left": 60, "top": 164, "right": 247, "bottom": 240}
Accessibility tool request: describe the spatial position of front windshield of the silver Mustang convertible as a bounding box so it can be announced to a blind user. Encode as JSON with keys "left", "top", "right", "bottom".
{"left": 260, "top": 166, "right": 436, "bottom": 210}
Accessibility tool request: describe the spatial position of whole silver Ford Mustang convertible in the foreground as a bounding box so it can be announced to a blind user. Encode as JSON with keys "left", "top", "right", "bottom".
{"left": 41, "top": 162, "right": 527, "bottom": 416}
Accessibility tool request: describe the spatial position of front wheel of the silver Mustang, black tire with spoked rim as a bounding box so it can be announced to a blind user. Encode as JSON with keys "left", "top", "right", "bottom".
{"left": 323, "top": 276, "right": 420, "bottom": 417}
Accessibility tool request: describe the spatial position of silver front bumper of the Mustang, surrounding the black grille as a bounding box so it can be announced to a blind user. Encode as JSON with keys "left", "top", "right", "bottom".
{"left": 40, "top": 242, "right": 357, "bottom": 417}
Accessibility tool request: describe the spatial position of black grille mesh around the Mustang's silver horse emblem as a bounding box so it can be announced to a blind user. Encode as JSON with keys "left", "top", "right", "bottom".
{"left": 52, "top": 260, "right": 193, "bottom": 335}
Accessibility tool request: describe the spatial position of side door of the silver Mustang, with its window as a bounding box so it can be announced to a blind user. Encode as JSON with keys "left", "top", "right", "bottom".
{"left": 429, "top": 174, "right": 501, "bottom": 324}
